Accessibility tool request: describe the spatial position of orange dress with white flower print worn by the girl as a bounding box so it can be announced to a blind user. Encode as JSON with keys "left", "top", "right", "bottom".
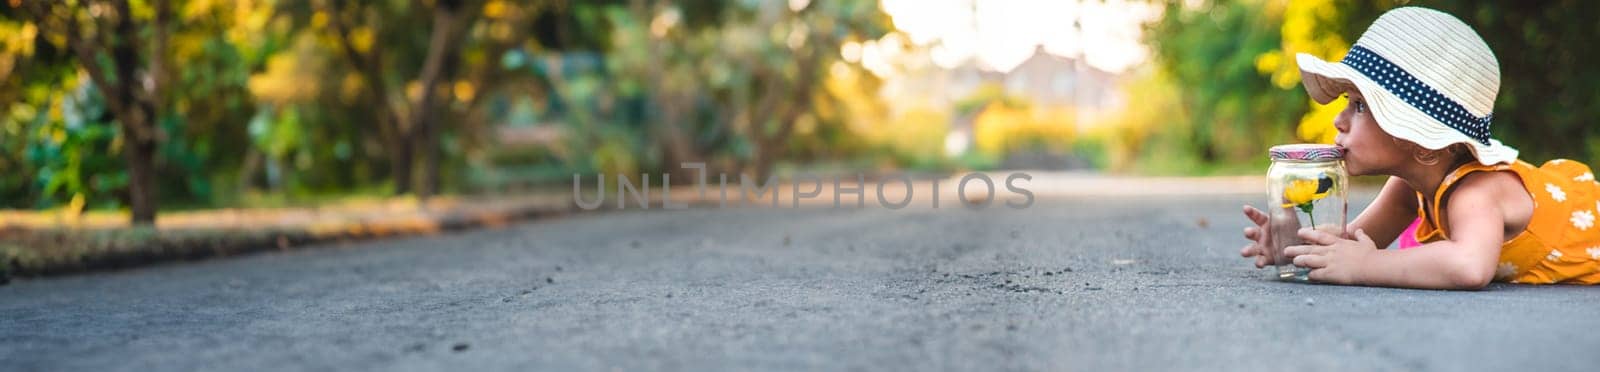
{"left": 1416, "top": 159, "right": 1600, "bottom": 284}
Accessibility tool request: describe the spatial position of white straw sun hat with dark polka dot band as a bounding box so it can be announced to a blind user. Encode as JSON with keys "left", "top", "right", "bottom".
{"left": 1294, "top": 6, "right": 1517, "bottom": 165}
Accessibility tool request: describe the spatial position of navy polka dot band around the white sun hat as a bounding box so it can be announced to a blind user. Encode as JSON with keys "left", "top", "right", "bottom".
{"left": 1341, "top": 45, "right": 1494, "bottom": 146}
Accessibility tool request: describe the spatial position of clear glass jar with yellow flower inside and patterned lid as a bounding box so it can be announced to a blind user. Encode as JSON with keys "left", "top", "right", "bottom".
{"left": 1264, "top": 144, "right": 1349, "bottom": 281}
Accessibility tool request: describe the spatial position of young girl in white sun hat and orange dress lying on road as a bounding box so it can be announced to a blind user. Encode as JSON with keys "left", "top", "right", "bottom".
{"left": 1240, "top": 8, "right": 1600, "bottom": 289}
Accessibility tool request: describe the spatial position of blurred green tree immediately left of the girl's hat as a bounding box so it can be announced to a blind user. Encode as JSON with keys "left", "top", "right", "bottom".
{"left": 1146, "top": 0, "right": 1307, "bottom": 164}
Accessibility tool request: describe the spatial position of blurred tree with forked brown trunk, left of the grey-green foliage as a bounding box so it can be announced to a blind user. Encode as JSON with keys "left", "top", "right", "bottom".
{"left": 256, "top": 0, "right": 588, "bottom": 197}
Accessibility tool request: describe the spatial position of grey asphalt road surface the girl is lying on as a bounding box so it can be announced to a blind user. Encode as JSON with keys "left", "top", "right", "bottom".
{"left": 0, "top": 190, "right": 1600, "bottom": 372}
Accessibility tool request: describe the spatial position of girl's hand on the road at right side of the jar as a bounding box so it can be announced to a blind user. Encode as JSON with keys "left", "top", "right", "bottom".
{"left": 1283, "top": 228, "right": 1378, "bottom": 285}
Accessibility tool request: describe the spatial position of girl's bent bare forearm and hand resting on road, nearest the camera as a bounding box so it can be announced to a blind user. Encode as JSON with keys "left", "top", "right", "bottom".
{"left": 1285, "top": 173, "right": 1522, "bottom": 289}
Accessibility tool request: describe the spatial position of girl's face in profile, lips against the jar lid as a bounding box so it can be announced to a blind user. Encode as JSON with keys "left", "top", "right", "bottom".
{"left": 1333, "top": 87, "right": 1411, "bottom": 175}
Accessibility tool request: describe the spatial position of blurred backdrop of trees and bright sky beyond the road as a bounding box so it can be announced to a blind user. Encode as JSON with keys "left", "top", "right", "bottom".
{"left": 0, "top": 0, "right": 1600, "bottom": 221}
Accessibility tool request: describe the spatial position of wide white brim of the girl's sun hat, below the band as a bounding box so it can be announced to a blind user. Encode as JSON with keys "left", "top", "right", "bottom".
{"left": 1294, "top": 53, "right": 1517, "bottom": 165}
